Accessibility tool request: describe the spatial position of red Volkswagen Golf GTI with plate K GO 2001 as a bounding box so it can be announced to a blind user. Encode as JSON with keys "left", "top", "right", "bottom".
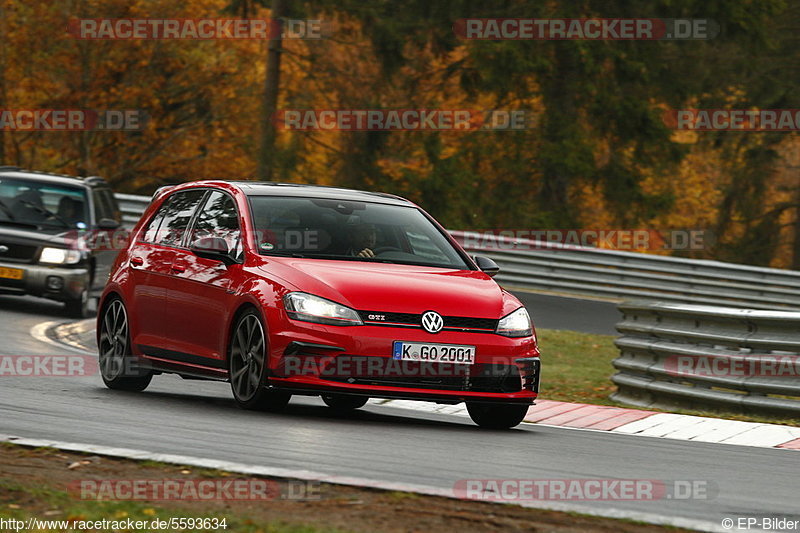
{"left": 97, "top": 181, "right": 540, "bottom": 428}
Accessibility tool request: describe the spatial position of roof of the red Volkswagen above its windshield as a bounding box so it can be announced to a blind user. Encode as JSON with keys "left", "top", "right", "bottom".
{"left": 225, "top": 180, "right": 414, "bottom": 206}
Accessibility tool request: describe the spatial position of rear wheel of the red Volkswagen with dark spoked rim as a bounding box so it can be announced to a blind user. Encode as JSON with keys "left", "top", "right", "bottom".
{"left": 97, "top": 298, "right": 153, "bottom": 392}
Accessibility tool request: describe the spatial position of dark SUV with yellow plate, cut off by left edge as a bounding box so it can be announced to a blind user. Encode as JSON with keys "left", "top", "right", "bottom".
{"left": 0, "top": 167, "right": 122, "bottom": 317}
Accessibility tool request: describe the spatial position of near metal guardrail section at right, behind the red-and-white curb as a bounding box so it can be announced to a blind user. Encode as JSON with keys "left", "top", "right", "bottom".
{"left": 611, "top": 302, "right": 800, "bottom": 415}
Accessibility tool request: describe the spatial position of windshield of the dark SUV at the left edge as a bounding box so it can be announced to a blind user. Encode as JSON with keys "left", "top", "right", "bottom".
{"left": 0, "top": 178, "right": 88, "bottom": 228}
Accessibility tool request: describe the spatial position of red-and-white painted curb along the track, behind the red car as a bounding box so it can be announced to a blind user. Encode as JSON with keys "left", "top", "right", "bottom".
{"left": 376, "top": 400, "right": 800, "bottom": 450}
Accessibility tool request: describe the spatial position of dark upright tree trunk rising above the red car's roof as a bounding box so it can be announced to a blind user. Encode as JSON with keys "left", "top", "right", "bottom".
{"left": 258, "top": 0, "right": 286, "bottom": 181}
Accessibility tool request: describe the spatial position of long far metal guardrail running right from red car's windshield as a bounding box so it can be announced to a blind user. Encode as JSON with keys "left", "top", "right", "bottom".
{"left": 451, "top": 231, "right": 800, "bottom": 309}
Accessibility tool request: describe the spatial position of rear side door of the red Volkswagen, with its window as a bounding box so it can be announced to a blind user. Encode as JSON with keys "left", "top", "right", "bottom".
{"left": 129, "top": 189, "right": 205, "bottom": 357}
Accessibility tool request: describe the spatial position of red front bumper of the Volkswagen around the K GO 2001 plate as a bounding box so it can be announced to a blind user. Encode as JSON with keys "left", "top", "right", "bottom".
{"left": 269, "top": 310, "right": 541, "bottom": 404}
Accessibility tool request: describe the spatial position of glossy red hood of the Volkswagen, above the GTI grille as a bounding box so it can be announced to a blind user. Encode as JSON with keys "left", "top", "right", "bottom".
{"left": 260, "top": 258, "right": 519, "bottom": 318}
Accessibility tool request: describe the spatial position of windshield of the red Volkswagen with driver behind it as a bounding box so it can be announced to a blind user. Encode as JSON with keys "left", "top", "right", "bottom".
{"left": 250, "top": 196, "right": 469, "bottom": 270}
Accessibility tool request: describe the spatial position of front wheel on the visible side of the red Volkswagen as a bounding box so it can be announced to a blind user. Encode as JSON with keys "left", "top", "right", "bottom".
{"left": 228, "top": 309, "right": 291, "bottom": 411}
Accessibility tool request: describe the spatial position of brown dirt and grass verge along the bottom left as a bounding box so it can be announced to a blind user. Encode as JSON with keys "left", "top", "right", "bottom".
{"left": 0, "top": 444, "right": 679, "bottom": 533}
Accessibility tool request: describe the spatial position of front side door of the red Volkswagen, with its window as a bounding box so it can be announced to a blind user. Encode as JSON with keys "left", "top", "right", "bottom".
{"left": 159, "top": 190, "right": 242, "bottom": 368}
